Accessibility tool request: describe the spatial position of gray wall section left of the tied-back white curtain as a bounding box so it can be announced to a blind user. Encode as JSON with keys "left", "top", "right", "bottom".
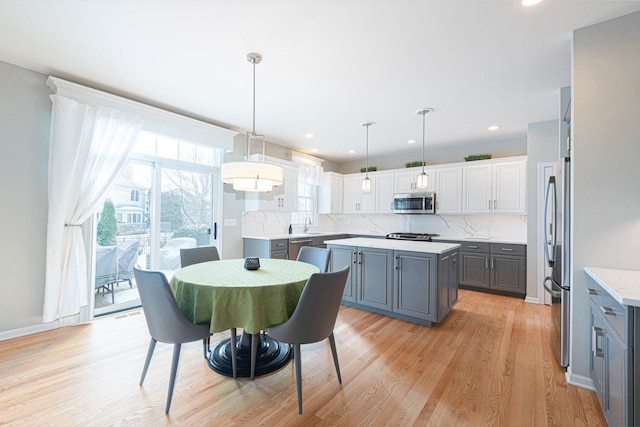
{"left": 0, "top": 62, "right": 51, "bottom": 332}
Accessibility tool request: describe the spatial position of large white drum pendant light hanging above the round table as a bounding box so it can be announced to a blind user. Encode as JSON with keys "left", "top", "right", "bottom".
{"left": 220, "top": 53, "right": 283, "bottom": 192}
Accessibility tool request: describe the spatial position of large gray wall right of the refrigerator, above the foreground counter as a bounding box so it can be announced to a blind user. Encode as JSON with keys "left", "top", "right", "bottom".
{"left": 570, "top": 12, "right": 640, "bottom": 377}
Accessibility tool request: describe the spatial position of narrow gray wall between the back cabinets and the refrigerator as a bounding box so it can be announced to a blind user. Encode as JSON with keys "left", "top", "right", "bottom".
{"left": 527, "top": 118, "right": 560, "bottom": 302}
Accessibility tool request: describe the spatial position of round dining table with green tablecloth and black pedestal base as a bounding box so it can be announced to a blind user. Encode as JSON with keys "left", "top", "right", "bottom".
{"left": 170, "top": 259, "right": 320, "bottom": 377}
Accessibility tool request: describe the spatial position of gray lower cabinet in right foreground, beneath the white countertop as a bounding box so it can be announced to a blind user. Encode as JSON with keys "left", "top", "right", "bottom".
{"left": 587, "top": 281, "right": 640, "bottom": 426}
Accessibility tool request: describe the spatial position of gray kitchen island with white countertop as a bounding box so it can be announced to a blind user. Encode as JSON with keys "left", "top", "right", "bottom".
{"left": 325, "top": 238, "right": 460, "bottom": 326}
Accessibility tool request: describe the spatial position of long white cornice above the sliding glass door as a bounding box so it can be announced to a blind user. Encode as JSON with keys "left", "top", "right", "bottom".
{"left": 46, "top": 76, "right": 238, "bottom": 151}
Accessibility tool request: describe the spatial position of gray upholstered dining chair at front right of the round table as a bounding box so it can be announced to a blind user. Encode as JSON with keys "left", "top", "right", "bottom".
{"left": 267, "top": 265, "right": 350, "bottom": 414}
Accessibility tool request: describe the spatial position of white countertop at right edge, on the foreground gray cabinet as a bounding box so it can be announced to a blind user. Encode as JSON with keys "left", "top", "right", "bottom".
{"left": 584, "top": 267, "right": 640, "bottom": 307}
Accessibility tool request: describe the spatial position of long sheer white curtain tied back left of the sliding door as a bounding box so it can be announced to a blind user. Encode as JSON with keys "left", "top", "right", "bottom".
{"left": 42, "top": 95, "right": 144, "bottom": 322}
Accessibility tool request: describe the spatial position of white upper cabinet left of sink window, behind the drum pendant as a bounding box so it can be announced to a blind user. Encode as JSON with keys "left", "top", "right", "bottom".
{"left": 245, "top": 166, "right": 298, "bottom": 212}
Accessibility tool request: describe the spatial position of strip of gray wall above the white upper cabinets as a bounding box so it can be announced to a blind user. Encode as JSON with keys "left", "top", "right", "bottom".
{"left": 336, "top": 138, "right": 527, "bottom": 173}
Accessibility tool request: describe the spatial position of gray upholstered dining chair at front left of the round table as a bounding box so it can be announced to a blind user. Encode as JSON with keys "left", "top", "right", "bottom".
{"left": 133, "top": 267, "right": 235, "bottom": 413}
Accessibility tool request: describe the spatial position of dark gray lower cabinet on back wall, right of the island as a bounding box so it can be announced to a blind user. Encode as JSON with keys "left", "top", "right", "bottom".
{"left": 460, "top": 242, "right": 527, "bottom": 296}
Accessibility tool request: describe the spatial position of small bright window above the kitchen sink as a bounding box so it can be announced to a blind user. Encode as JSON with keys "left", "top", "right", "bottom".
{"left": 291, "top": 153, "right": 322, "bottom": 225}
